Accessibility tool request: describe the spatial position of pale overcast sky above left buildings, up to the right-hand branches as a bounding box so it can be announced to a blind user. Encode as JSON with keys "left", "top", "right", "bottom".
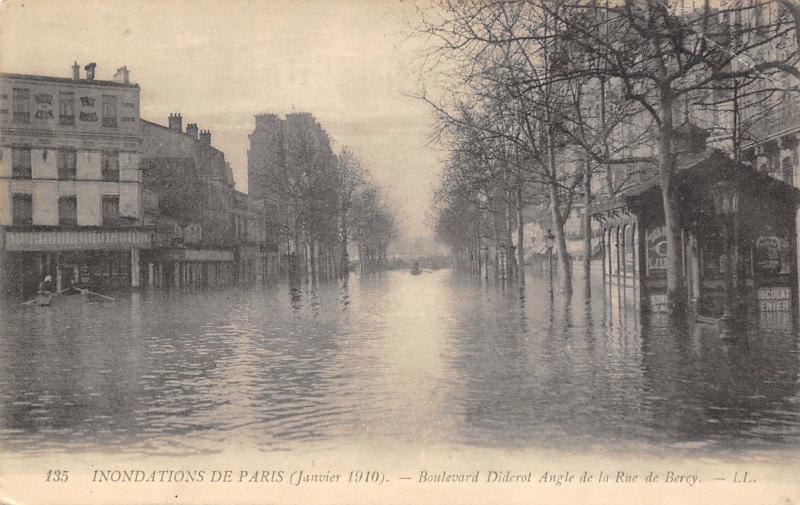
{"left": 0, "top": 0, "right": 440, "bottom": 235}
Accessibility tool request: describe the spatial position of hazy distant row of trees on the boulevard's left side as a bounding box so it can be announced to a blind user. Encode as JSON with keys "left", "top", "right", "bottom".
{"left": 251, "top": 114, "right": 396, "bottom": 279}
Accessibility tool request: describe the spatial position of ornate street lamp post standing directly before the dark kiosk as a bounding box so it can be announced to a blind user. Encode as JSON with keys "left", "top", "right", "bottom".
{"left": 711, "top": 180, "right": 739, "bottom": 335}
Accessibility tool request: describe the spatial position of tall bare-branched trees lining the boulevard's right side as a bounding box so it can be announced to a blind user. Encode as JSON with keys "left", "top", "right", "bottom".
{"left": 418, "top": 0, "right": 800, "bottom": 311}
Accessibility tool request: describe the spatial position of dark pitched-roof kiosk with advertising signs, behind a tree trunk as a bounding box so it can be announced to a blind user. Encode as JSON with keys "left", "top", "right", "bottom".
{"left": 593, "top": 152, "right": 800, "bottom": 322}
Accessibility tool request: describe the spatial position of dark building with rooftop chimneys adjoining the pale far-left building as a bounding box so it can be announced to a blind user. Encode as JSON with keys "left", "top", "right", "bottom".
{"left": 142, "top": 114, "right": 236, "bottom": 287}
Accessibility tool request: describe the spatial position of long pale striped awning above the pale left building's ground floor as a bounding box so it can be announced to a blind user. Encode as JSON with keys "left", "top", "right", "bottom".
{"left": 5, "top": 226, "right": 155, "bottom": 251}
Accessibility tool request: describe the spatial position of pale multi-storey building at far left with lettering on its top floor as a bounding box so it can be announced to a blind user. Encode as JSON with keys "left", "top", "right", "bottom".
{"left": 0, "top": 63, "right": 151, "bottom": 296}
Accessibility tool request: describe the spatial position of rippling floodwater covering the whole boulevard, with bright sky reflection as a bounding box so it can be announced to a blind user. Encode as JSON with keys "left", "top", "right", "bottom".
{"left": 0, "top": 270, "right": 800, "bottom": 454}
